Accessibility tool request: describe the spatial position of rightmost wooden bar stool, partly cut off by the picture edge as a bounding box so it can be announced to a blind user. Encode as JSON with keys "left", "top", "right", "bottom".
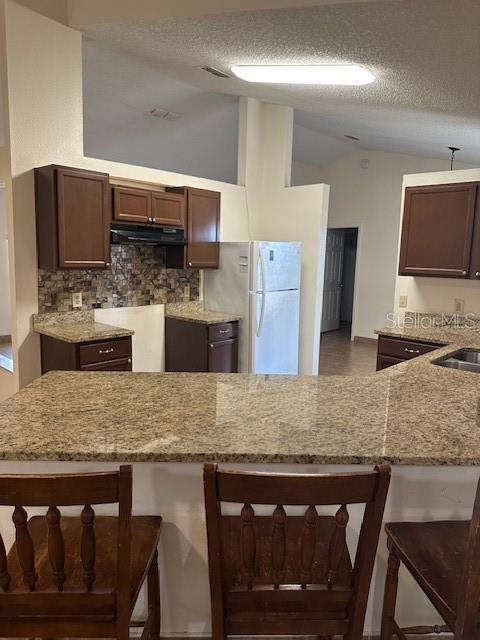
{"left": 381, "top": 483, "right": 480, "bottom": 640}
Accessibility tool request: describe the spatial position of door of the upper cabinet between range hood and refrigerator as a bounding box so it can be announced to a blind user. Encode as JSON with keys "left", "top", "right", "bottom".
{"left": 187, "top": 189, "right": 220, "bottom": 269}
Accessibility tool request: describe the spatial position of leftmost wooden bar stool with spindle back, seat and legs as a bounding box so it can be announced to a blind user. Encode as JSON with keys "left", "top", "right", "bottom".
{"left": 0, "top": 466, "right": 162, "bottom": 640}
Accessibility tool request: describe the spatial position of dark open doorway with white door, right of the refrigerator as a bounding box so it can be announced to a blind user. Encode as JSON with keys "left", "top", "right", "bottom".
{"left": 322, "top": 227, "right": 358, "bottom": 337}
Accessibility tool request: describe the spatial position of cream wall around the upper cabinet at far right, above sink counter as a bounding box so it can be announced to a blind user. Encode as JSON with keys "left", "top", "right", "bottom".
{"left": 394, "top": 169, "right": 480, "bottom": 314}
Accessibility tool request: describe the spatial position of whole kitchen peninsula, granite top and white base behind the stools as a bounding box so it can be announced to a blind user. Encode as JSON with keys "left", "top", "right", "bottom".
{"left": 0, "top": 340, "right": 480, "bottom": 635}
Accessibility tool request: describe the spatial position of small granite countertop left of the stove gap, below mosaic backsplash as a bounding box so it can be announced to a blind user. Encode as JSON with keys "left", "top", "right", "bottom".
{"left": 33, "top": 310, "right": 135, "bottom": 343}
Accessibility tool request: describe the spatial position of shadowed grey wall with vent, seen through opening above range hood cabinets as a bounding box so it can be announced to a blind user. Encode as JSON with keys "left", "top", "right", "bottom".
{"left": 83, "top": 39, "right": 238, "bottom": 183}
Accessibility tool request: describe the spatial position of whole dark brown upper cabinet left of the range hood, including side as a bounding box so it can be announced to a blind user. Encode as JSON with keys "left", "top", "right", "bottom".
{"left": 35, "top": 165, "right": 111, "bottom": 271}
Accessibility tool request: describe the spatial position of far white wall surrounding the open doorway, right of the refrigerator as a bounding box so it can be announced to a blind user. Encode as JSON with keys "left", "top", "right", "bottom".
{"left": 323, "top": 149, "right": 475, "bottom": 338}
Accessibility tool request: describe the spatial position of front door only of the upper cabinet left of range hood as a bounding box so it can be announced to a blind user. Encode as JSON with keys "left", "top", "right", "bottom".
{"left": 57, "top": 168, "right": 111, "bottom": 269}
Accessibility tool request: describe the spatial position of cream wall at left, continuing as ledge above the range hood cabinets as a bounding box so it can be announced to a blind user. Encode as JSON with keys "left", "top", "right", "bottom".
{"left": 0, "top": 0, "right": 248, "bottom": 395}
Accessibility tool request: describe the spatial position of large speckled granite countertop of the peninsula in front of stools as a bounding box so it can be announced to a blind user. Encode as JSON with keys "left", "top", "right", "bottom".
{"left": 0, "top": 342, "right": 480, "bottom": 465}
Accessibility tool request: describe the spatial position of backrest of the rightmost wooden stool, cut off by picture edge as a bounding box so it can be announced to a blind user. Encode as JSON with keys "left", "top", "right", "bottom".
{"left": 454, "top": 480, "right": 480, "bottom": 640}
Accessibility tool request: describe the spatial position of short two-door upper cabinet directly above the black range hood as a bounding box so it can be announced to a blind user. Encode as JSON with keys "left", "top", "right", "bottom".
{"left": 113, "top": 186, "right": 185, "bottom": 227}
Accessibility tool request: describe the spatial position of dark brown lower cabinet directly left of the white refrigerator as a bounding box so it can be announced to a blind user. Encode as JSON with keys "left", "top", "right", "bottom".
{"left": 165, "top": 318, "right": 238, "bottom": 373}
